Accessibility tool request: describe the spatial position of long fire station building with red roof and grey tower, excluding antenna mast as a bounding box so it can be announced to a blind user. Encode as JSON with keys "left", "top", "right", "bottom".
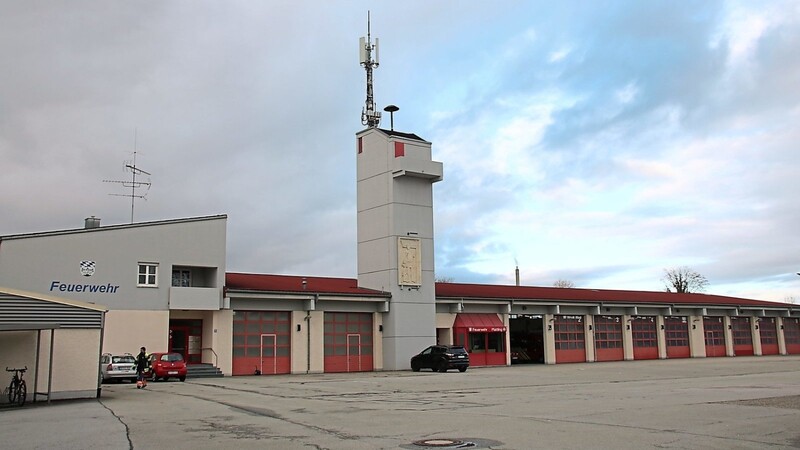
{"left": 0, "top": 127, "right": 800, "bottom": 384}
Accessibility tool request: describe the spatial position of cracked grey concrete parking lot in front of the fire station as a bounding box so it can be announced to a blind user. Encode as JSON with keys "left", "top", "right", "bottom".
{"left": 0, "top": 356, "right": 800, "bottom": 450}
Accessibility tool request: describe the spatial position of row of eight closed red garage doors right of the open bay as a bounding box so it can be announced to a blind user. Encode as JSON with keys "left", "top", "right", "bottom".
{"left": 553, "top": 315, "right": 800, "bottom": 363}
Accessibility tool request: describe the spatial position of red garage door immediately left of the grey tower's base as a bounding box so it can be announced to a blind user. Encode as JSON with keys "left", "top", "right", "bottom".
{"left": 325, "top": 312, "right": 373, "bottom": 372}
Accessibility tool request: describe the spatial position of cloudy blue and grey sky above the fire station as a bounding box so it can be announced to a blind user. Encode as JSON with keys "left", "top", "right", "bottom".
{"left": 0, "top": 0, "right": 800, "bottom": 301}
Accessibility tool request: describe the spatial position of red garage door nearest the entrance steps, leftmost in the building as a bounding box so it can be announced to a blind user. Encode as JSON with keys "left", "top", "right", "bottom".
{"left": 233, "top": 311, "right": 291, "bottom": 375}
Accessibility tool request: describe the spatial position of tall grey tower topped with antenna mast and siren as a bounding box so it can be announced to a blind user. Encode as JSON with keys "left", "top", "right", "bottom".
{"left": 355, "top": 14, "right": 444, "bottom": 370}
